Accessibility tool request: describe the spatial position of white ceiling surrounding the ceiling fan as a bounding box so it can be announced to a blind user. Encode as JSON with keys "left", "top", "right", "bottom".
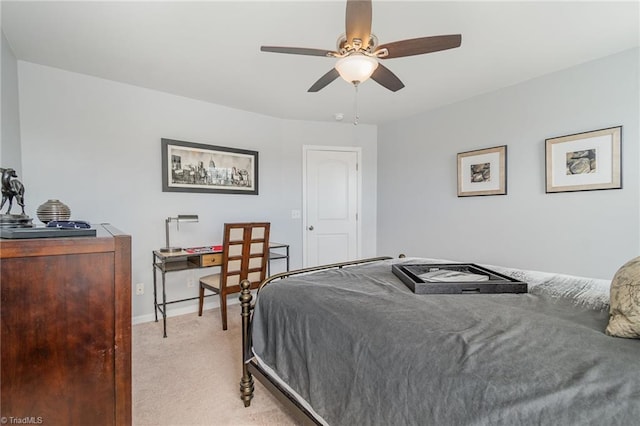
{"left": 1, "top": 0, "right": 640, "bottom": 123}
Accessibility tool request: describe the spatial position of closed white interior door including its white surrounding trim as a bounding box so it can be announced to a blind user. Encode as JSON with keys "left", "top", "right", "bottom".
{"left": 303, "top": 147, "right": 360, "bottom": 267}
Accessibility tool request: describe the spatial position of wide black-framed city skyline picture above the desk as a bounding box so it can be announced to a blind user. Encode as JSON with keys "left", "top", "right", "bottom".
{"left": 162, "top": 139, "right": 258, "bottom": 195}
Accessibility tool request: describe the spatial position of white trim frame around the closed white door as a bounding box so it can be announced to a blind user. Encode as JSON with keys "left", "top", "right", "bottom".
{"left": 302, "top": 145, "right": 362, "bottom": 268}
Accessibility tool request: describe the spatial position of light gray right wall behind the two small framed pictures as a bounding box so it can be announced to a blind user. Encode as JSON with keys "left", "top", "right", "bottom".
{"left": 378, "top": 49, "right": 640, "bottom": 279}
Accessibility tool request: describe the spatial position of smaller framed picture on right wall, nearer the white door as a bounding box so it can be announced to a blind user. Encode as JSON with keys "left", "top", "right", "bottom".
{"left": 458, "top": 145, "right": 507, "bottom": 197}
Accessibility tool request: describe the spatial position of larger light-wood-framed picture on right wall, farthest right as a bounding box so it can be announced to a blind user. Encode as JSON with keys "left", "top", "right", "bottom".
{"left": 545, "top": 126, "right": 622, "bottom": 193}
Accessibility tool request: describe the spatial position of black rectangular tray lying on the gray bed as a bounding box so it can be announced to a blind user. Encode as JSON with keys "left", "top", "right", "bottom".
{"left": 391, "top": 263, "right": 527, "bottom": 294}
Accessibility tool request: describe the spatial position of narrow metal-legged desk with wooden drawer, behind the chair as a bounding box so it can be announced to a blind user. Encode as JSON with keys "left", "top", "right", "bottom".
{"left": 153, "top": 242, "right": 289, "bottom": 337}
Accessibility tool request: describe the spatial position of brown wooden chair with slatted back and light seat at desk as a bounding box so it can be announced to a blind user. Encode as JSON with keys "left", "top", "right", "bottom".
{"left": 198, "top": 222, "right": 270, "bottom": 330}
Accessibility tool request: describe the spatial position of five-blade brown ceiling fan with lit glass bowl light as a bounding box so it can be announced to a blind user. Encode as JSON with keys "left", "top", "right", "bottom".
{"left": 260, "top": 0, "right": 462, "bottom": 92}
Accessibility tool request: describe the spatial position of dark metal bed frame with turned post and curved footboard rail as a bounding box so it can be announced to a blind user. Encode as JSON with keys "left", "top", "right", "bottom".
{"left": 240, "top": 256, "right": 392, "bottom": 425}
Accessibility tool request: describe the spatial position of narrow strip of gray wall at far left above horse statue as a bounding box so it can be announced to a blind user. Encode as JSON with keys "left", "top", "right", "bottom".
{"left": 0, "top": 31, "right": 22, "bottom": 175}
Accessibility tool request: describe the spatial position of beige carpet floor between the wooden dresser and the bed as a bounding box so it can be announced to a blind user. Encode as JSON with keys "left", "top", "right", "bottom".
{"left": 132, "top": 305, "right": 296, "bottom": 426}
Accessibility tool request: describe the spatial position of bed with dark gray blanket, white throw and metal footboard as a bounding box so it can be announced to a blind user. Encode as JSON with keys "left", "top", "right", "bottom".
{"left": 240, "top": 258, "right": 640, "bottom": 425}
